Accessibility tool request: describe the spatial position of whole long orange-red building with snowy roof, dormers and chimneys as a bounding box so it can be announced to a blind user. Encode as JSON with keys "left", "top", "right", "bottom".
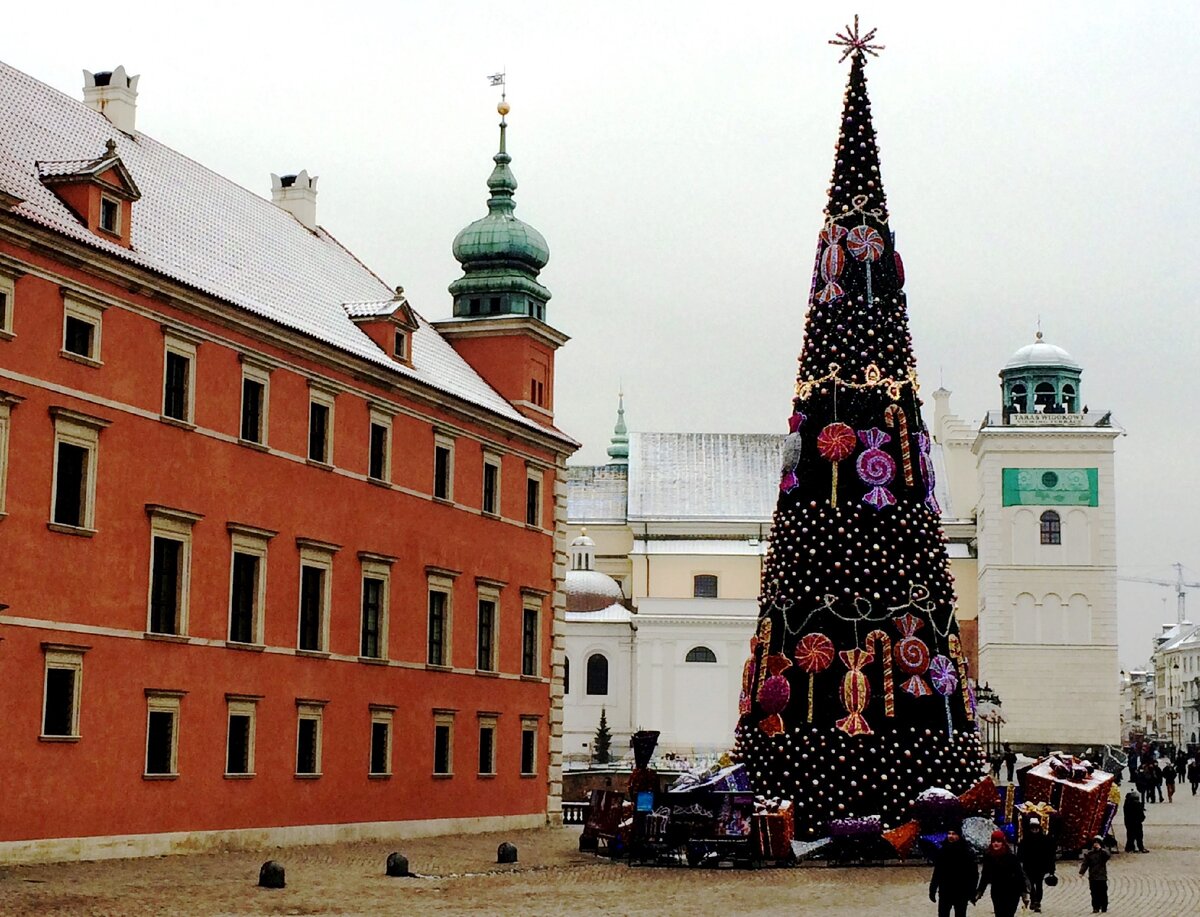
{"left": 0, "top": 65, "right": 575, "bottom": 861}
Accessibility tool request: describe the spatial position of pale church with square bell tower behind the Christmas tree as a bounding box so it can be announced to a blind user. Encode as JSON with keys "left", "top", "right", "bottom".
{"left": 563, "top": 332, "right": 1121, "bottom": 766}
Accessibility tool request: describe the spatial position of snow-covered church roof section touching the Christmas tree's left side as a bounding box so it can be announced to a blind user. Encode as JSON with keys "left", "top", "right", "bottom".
{"left": 629, "top": 433, "right": 784, "bottom": 522}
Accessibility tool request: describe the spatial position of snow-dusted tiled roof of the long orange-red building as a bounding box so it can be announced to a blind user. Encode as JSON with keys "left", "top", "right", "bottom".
{"left": 0, "top": 64, "right": 565, "bottom": 439}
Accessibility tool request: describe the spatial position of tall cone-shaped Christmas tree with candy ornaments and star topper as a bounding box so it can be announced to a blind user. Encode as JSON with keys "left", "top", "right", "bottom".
{"left": 737, "top": 17, "right": 982, "bottom": 839}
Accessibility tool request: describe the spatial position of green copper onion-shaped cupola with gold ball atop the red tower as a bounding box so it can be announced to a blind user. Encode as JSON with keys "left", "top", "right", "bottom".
{"left": 450, "top": 101, "right": 550, "bottom": 322}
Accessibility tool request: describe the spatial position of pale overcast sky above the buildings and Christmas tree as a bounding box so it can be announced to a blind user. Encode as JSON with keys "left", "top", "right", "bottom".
{"left": 0, "top": 0, "right": 1200, "bottom": 667}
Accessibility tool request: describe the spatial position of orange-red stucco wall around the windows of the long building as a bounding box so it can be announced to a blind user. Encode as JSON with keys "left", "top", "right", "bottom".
{"left": 0, "top": 236, "right": 562, "bottom": 841}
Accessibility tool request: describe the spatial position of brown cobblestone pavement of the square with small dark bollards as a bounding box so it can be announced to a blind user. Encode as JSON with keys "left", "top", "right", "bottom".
{"left": 0, "top": 786, "right": 1200, "bottom": 917}
